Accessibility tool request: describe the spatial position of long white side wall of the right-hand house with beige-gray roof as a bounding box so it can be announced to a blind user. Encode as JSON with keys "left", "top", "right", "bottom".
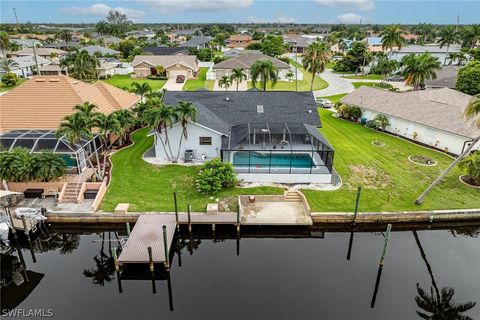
{"left": 362, "top": 110, "right": 474, "bottom": 154}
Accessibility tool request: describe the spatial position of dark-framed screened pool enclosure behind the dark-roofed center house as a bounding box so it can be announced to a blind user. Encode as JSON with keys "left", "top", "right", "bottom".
{"left": 222, "top": 122, "right": 335, "bottom": 174}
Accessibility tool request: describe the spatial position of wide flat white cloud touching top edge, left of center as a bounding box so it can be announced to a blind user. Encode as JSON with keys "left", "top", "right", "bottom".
{"left": 134, "top": 0, "right": 254, "bottom": 14}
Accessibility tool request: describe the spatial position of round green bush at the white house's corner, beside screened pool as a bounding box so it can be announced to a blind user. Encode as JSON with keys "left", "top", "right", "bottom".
{"left": 195, "top": 158, "right": 237, "bottom": 194}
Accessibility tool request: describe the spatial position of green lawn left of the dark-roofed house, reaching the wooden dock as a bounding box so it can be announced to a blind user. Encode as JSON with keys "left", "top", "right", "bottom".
{"left": 101, "top": 128, "right": 283, "bottom": 211}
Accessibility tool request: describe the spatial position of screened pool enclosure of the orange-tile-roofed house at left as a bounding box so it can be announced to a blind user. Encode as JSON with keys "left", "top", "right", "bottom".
{"left": 0, "top": 130, "right": 103, "bottom": 173}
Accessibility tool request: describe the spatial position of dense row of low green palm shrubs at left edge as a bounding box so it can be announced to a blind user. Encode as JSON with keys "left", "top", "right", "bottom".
{"left": 0, "top": 148, "right": 65, "bottom": 182}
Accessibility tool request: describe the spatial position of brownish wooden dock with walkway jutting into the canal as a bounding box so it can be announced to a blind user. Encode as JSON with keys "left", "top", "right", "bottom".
{"left": 118, "top": 212, "right": 237, "bottom": 264}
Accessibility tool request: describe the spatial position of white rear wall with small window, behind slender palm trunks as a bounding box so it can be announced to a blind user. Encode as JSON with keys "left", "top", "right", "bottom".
{"left": 155, "top": 123, "right": 222, "bottom": 161}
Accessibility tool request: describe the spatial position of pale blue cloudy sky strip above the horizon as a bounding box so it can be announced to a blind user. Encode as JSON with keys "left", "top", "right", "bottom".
{"left": 0, "top": 0, "right": 480, "bottom": 24}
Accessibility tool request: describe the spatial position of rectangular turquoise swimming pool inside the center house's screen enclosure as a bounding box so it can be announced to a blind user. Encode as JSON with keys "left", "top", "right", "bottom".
{"left": 233, "top": 151, "right": 315, "bottom": 168}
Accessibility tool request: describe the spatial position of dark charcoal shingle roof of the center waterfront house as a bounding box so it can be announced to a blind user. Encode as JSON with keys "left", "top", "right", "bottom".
{"left": 165, "top": 91, "right": 321, "bottom": 134}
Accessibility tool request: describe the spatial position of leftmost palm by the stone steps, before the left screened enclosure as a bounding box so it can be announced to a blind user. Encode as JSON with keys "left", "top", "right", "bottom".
{"left": 55, "top": 112, "right": 102, "bottom": 180}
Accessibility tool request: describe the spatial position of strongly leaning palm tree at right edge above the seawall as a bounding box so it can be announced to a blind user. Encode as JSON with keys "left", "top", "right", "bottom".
{"left": 415, "top": 94, "right": 480, "bottom": 204}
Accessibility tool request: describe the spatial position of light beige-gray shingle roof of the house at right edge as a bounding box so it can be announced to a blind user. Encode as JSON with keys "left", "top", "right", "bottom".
{"left": 342, "top": 87, "right": 480, "bottom": 138}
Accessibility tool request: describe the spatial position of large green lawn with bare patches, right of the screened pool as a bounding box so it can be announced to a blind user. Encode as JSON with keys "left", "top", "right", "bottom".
{"left": 303, "top": 109, "right": 480, "bottom": 211}
